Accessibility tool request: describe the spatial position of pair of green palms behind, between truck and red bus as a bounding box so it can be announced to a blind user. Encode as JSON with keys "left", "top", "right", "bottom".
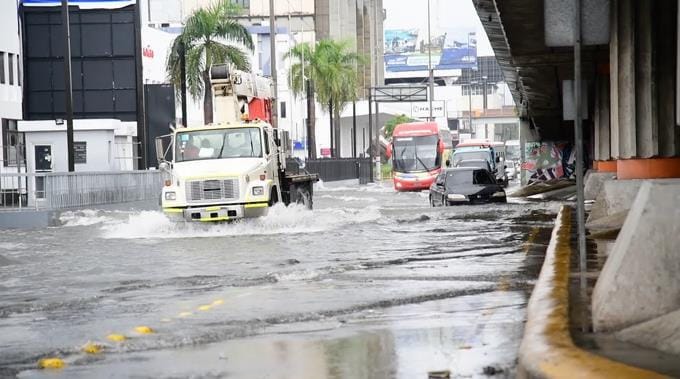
{"left": 287, "top": 39, "right": 362, "bottom": 158}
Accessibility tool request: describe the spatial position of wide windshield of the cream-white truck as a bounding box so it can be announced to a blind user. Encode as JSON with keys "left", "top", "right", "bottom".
{"left": 175, "top": 128, "right": 262, "bottom": 162}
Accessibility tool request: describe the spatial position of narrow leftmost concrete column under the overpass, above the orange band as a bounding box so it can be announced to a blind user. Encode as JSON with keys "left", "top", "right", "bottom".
{"left": 609, "top": 0, "right": 619, "bottom": 158}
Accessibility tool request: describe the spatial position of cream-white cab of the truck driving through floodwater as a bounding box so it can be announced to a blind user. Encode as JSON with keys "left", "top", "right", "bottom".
{"left": 161, "top": 122, "right": 285, "bottom": 221}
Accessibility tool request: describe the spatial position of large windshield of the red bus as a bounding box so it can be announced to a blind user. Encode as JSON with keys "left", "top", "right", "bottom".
{"left": 392, "top": 135, "right": 439, "bottom": 172}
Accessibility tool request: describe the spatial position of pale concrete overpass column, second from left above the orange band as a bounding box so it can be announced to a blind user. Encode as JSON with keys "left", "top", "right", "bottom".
{"left": 617, "top": 0, "right": 637, "bottom": 159}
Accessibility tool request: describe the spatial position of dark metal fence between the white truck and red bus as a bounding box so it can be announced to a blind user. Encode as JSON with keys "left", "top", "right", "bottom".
{"left": 305, "top": 158, "right": 371, "bottom": 184}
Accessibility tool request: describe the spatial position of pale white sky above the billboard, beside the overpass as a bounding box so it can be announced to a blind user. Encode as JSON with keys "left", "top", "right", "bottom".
{"left": 383, "top": 0, "right": 494, "bottom": 56}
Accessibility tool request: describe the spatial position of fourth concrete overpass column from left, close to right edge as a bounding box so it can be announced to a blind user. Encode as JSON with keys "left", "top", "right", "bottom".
{"left": 654, "top": 1, "right": 680, "bottom": 157}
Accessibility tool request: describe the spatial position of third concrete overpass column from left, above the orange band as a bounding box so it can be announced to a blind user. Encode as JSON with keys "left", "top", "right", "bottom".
{"left": 634, "top": 1, "right": 659, "bottom": 158}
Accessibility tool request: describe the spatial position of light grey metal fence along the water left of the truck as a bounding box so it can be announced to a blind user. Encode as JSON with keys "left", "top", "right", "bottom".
{"left": 0, "top": 170, "right": 162, "bottom": 209}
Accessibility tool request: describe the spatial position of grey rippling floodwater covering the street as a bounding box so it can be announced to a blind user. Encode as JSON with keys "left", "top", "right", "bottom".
{"left": 0, "top": 183, "right": 559, "bottom": 379}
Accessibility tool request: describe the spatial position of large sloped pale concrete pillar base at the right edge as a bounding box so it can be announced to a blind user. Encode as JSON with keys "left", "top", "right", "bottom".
{"left": 592, "top": 180, "right": 680, "bottom": 331}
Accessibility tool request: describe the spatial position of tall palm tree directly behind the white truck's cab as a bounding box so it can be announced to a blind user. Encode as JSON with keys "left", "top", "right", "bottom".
{"left": 166, "top": 0, "right": 253, "bottom": 124}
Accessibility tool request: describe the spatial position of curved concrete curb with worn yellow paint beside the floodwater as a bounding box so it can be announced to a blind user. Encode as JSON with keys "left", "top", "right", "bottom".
{"left": 517, "top": 205, "right": 665, "bottom": 379}
